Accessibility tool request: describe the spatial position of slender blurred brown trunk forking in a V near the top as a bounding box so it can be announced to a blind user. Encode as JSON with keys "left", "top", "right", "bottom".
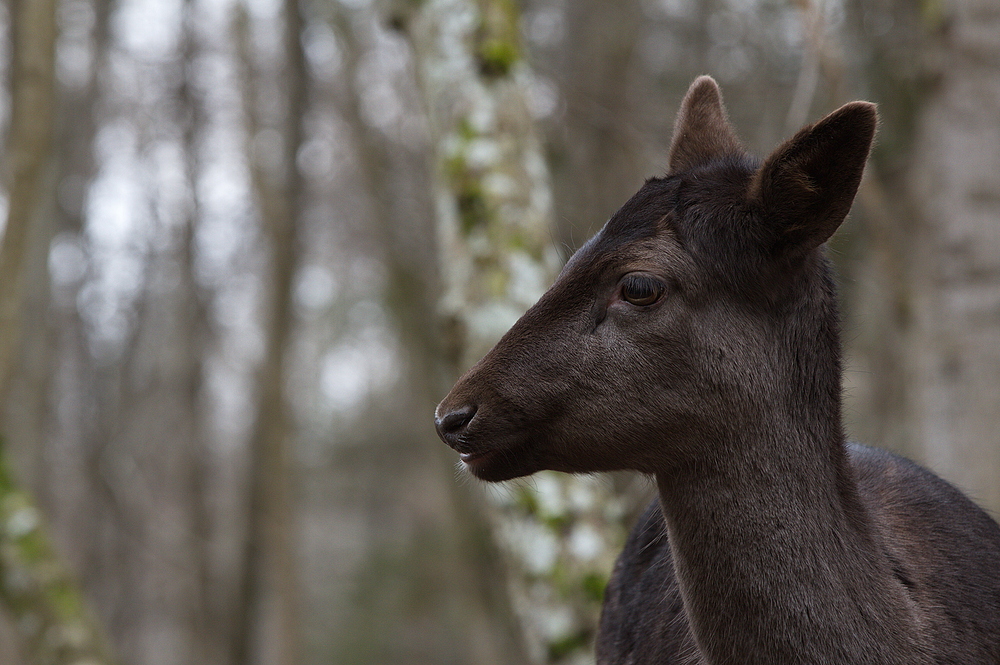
{"left": 231, "top": 0, "right": 307, "bottom": 665}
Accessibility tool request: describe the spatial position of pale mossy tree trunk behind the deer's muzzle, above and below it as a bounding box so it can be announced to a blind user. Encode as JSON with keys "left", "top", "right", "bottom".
{"left": 392, "top": 0, "right": 621, "bottom": 662}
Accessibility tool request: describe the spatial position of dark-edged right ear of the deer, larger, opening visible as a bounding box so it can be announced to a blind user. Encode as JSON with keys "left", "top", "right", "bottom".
{"left": 750, "top": 102, "right": 878, "bottom": 254}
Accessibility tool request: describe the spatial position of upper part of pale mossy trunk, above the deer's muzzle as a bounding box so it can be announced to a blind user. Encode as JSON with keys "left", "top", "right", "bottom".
{"left": 394, "top": 0, "right": 559, "bottom": 369}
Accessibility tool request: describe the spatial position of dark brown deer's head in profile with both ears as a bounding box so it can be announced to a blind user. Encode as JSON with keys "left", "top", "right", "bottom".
{"left": 435, "top": 76, "right": 876, "bottom": 481}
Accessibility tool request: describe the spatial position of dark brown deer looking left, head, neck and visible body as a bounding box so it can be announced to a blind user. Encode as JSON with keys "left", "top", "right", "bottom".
{"left": 435, "top": 76, "right": 1000, "bottom": 665}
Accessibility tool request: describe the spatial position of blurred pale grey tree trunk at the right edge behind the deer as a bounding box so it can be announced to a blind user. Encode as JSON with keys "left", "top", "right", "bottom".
{"left": 907, "top": 0, "right": 1000, "bottom": 511}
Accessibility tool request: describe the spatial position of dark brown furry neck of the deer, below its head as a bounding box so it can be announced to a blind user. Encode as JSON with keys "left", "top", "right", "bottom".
{"left": 656, "top": 423, "right": 921, "bottom": 665}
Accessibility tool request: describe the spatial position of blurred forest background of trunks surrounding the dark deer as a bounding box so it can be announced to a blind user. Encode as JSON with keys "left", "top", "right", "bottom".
{"left": 0, "top": 0, "right": 1000, "bottom": 665}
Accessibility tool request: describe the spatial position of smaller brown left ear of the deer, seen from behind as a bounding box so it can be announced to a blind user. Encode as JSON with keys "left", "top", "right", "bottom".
{"left": 670, "top": 76, "right": 744, "bottom": 173}
